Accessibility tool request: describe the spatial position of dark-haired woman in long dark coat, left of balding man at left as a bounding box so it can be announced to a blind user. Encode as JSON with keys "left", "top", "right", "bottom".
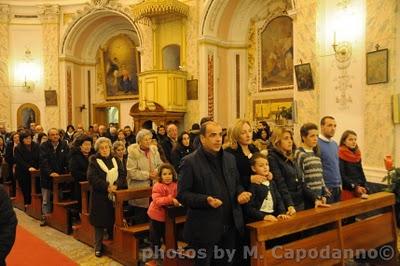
{"left": 14, "top": 131, "right": 40, "bottom": 207}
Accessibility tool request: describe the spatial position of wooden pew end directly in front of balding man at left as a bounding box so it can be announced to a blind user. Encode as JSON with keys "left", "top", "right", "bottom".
{"left": 46, "top": 174, "right": 78, "bottom": 234}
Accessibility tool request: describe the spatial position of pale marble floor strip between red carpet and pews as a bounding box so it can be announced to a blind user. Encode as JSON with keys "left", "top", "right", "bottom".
{"left": 15, "top": 209, "right": 122, "bottom": 266}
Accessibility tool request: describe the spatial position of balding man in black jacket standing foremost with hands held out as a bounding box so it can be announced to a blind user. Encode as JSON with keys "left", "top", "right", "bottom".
{"left": 178, "top": 121, "right": 251, "bottom": 265}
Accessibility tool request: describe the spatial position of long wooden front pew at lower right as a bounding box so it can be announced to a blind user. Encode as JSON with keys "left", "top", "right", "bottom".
{"left": 247, "top": 192, "right": 397, "bottom": 266}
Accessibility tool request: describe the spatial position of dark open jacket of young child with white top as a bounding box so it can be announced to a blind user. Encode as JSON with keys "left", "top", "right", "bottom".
{"left": 243, "top": 180, "right": 286, "bottom": 223}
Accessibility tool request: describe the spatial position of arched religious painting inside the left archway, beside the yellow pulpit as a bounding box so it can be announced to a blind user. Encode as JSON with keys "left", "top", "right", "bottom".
{"left": 101, "top": 34, "right": 139, "bottom": 100}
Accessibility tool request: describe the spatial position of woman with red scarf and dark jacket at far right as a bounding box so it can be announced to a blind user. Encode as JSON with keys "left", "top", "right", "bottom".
{"left": 339, "top": 130, "right": 368, "bottom": 200}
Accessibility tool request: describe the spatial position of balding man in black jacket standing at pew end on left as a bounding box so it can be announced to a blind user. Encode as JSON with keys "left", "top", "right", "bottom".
{"left": 40, "top": 128, "right": 69, "bottom": 226}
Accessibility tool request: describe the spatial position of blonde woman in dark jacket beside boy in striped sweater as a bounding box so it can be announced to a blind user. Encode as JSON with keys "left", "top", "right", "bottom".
{"left": 268, "top": 128, "right": 304, "bottom": 215}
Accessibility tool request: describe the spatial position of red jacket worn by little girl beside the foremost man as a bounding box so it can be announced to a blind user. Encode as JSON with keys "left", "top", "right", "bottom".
{"left": 147, "top": 182, "right": 177, "bottom": 222}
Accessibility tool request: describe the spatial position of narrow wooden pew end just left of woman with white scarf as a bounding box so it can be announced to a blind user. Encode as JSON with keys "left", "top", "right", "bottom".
{"left": 72, "top": 181, "right": 94, "bottom": 246}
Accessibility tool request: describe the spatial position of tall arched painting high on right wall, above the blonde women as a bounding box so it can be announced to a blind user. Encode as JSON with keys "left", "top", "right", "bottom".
{"left": 259, "top": 16, "right": 293, "bottom": 91}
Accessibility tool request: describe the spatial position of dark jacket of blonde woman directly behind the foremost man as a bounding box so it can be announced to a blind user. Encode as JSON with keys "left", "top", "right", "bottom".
{"left": 225, "top": 144, "right": 258, "bottom": 190}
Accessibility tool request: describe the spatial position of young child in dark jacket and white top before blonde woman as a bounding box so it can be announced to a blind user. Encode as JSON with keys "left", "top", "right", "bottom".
{"left": 244, "top": 153, "right": 289, "bottom": 222}
